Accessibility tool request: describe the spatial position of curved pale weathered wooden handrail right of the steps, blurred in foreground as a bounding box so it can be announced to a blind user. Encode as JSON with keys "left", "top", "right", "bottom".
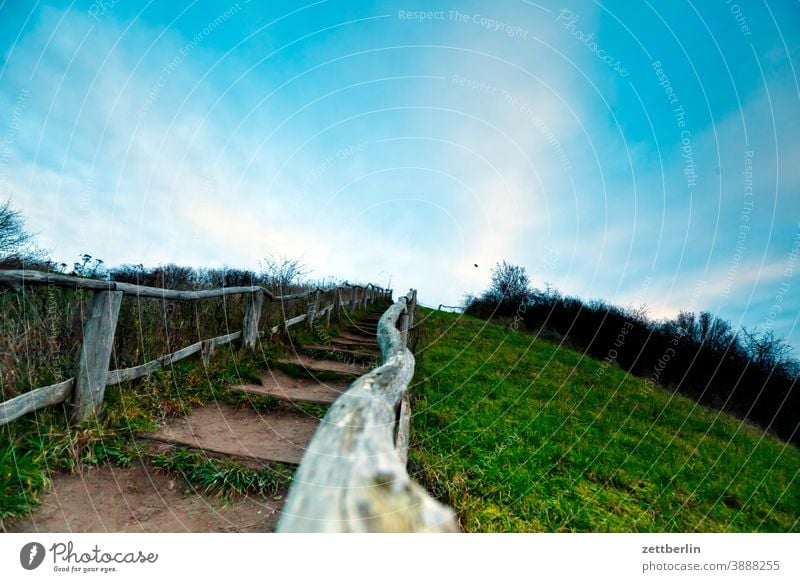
{"left": 278, "top": 291, "right": 458, "bottom": 532}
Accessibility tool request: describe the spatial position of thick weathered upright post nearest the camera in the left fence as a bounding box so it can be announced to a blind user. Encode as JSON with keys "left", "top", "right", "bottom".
{"left": 73, "top": 291, "right": 122, "bottom": 421}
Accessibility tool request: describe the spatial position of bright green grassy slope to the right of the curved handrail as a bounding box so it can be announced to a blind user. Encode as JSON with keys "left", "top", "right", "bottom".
{"left": 409, "top": 310, "right": 800, "bottom": 532}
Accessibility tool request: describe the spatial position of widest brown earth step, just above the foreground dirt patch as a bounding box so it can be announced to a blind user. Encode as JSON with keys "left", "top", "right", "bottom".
{"left": 140, "top": 404, "right": 319, "bottom": 465}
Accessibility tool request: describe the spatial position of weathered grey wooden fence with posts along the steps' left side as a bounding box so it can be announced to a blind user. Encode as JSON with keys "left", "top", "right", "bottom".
{"left": 0, "top": 270, "right": 391, "bottom": 426}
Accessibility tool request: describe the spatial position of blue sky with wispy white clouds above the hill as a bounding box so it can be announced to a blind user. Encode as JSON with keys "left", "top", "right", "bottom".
{"left": 0, "top": 0, "right": 800, "bottom": 346}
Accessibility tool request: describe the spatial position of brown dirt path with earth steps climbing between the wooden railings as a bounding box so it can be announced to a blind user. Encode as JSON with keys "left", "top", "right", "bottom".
{"left": 9, "top": 313, "right": 384, "bottom": 532}
